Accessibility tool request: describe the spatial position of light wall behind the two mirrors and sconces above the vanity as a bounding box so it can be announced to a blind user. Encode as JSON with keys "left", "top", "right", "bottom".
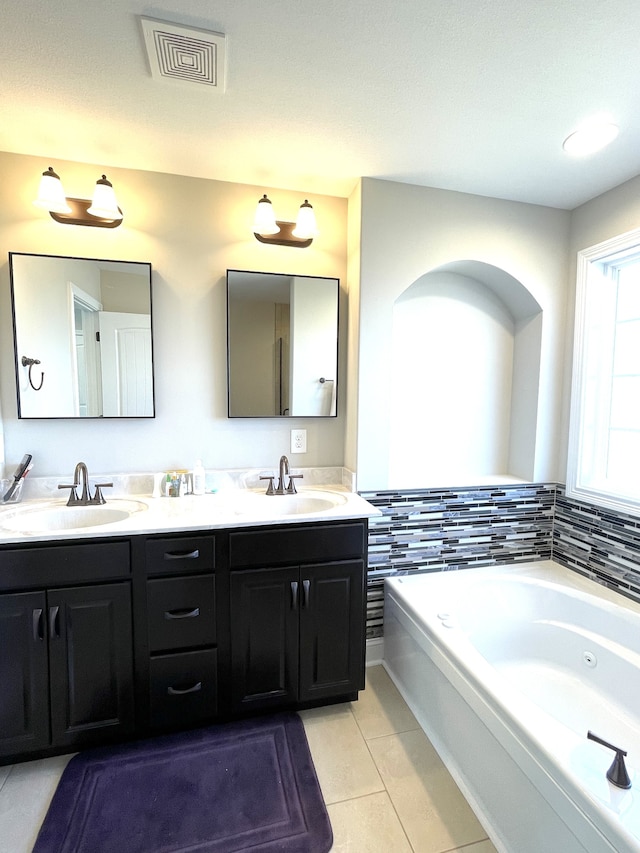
{"left": 0, "top": 153, "right": 347, "bottom": 477}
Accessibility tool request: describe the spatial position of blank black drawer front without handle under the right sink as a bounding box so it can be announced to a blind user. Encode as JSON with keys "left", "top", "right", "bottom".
{"left": 229, "top": 524, "right": 365, "bottom": 569}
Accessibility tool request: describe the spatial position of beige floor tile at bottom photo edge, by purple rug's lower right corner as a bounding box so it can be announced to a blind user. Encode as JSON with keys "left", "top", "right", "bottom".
{"left": 327, "top": 793, "right": 411, "bottom": 853}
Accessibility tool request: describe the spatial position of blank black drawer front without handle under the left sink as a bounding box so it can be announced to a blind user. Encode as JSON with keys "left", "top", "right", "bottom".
{"left": 0, "top": 542, "right": 131, "bottom": 591}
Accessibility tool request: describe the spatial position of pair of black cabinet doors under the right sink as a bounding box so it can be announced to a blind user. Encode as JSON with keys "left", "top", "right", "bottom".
{"left": 231, "top": 561, "right": 363, "bottom": 713}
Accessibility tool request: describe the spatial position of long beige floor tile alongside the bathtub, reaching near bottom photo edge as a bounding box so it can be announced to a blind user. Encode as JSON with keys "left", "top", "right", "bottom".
{"left": 368, "top": 731, "right": 487, "bottom": 853}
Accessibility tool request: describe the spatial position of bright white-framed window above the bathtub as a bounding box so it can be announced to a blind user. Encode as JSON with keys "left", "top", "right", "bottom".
{"left": 567, "top": 226, "right": 640, "bottom": 514}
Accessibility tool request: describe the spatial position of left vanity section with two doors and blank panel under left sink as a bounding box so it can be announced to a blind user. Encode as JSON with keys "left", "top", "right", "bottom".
{"left": 0, "top": 543, "right": 135, "bottom": 757}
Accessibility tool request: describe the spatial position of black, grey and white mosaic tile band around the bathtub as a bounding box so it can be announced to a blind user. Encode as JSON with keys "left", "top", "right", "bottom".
{"left": 361, "top": 483, "right": 640, "bottom": 638}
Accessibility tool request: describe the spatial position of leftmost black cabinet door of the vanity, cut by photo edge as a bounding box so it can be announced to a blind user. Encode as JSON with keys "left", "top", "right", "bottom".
{"left": 0, "top": 592, "right": 49, "bottom": 755}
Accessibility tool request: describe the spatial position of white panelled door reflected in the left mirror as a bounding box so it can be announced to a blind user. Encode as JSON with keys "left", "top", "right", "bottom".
{"left": 100, "top": 311, "right": 153, "bottom": 418}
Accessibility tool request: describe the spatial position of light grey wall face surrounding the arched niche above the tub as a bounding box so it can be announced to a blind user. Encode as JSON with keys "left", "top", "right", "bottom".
{"left": 356, "top": 178, "right": 570, "bottom": 490}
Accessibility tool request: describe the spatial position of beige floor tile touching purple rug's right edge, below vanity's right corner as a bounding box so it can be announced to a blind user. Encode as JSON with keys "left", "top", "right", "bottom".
{"left": 300, "top": 705, "right": 384, "bottom": 803}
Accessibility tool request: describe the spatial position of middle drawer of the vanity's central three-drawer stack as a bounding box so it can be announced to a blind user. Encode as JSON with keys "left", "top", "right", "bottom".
{"left": 147, "top": 574, "right": 216, "bottom": 652}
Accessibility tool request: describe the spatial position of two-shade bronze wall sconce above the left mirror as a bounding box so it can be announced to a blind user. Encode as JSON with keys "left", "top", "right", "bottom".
{"left": 33, "top": 166, "right": 123, "bottom": 228}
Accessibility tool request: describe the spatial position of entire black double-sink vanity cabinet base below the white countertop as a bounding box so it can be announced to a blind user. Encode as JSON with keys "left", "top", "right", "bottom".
{"left": 0, "top": 520, "right": 366, "bottom": 763}
